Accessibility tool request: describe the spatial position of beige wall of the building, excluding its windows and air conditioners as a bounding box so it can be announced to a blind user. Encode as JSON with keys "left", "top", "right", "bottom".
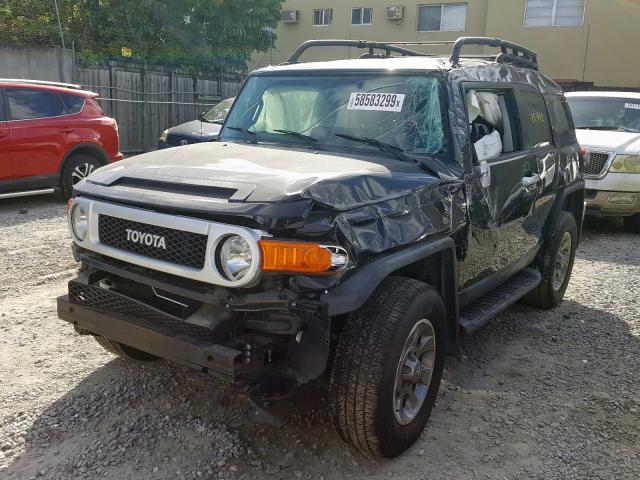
{"left": 262, "top": 0, "right": 640, "bottom": 89}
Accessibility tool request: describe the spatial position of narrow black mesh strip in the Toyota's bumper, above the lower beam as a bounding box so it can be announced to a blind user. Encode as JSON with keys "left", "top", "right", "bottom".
{"left": 69, "top": 282, "right": 211, "bottom": 338}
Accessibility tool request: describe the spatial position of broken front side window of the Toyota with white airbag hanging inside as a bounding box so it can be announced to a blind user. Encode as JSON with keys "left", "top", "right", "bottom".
{"left": 466, "top": 88, "right": 523, "bottom": 161}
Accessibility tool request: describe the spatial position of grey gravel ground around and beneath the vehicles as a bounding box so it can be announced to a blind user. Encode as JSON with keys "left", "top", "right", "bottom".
{"left": 0, "top": 196, "right": 640, "bottom": 480}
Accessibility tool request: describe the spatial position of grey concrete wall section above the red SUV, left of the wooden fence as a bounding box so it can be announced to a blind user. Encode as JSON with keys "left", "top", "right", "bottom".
{"left": 0, "top": 45, "right": 74, "bottom": 83}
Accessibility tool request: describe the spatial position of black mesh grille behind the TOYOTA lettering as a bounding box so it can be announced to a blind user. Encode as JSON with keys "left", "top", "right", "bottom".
{"left": 98, "top": 215, "right": 207, "bottom": 269}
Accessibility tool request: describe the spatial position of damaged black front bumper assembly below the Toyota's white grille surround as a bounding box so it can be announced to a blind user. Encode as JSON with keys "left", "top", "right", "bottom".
{"left": 58, "top": 255, "right": 330, "bottom": 391}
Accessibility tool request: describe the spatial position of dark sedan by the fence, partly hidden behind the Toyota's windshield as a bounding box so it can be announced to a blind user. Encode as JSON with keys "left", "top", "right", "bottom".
{"left": 158, "top": 98, "right": 235, "bottom": 148}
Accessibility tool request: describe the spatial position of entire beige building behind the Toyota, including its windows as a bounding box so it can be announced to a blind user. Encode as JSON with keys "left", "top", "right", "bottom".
{"left": 254, "top": 0, "right": 640, "bottom": 89}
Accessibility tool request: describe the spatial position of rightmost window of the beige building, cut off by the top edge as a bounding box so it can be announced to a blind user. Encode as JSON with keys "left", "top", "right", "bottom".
{"left": 524, "top": 0, "right": 586, "bottom": 27}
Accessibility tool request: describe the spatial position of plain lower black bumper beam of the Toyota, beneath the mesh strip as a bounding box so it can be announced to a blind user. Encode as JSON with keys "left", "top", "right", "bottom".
{"left": 58, "top": 295, "right": 242, "bottom": 382}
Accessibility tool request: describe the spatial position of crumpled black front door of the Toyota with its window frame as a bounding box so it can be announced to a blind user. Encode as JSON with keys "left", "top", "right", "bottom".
{"left": 459, "top": 82, "right": 540, "bottom": 294}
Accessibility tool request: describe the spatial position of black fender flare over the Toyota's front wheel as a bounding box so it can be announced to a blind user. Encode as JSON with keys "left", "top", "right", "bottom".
{"left": 324, "top": 237, "right": 459, "bottom": 342}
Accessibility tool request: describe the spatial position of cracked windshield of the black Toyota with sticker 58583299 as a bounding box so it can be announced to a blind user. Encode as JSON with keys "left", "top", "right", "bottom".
{"left": 224, "top": 75, "right": 447, "bottom": 155}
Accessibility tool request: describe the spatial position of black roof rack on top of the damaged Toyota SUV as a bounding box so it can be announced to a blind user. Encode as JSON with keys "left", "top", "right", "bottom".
{"left": 285, "top": 37, "right": 538, "bottom": 70}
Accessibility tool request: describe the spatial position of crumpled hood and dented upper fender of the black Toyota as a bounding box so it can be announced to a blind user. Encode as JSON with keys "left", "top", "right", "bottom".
{"left": 76, "top": 144, "right": 465, "bottom": 263}
